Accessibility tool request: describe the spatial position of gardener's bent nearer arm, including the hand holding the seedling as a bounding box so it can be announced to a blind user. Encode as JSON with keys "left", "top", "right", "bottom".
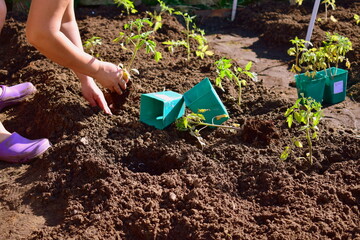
{"left": 26, "top": 0, "right": 126, "bottom": 101}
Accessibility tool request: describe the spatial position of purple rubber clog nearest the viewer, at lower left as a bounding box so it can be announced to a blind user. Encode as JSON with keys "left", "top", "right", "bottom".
{"left": 0, "top": 132, "right": 51, "bottom": 163}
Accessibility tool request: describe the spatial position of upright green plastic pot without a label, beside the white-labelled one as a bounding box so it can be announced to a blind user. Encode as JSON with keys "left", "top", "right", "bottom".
{"left": 295, "top": 72, "right": 326, "bottom": 103}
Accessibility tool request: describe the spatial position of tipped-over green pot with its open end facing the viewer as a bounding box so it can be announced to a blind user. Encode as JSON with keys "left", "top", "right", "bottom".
{"left": 140, "top": 91, "right": 185, "bottom": 129}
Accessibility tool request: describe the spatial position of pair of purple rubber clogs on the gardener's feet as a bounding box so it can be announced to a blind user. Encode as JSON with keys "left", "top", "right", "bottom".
{"left": 0, "top": 82, "right": 51, "bottom": 163}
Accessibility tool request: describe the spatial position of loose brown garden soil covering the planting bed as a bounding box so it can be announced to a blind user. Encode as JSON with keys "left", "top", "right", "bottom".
{"left": 0, "top": 1, "right": 360, "bottom": 240}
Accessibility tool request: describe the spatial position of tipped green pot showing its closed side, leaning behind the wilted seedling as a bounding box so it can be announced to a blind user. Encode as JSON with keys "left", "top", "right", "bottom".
{"left": 184, "top": 78, "right": 229, "bottom": 125}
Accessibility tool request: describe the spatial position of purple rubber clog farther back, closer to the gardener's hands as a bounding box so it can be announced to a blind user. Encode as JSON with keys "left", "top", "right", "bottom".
{"left": 0, "top": 82, "right": 36, "bottom": 111}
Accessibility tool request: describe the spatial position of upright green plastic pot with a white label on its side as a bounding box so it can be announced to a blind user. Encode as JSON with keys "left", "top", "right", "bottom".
{"left": 323, "top": 67, "right": 348, "bottom": 104}
